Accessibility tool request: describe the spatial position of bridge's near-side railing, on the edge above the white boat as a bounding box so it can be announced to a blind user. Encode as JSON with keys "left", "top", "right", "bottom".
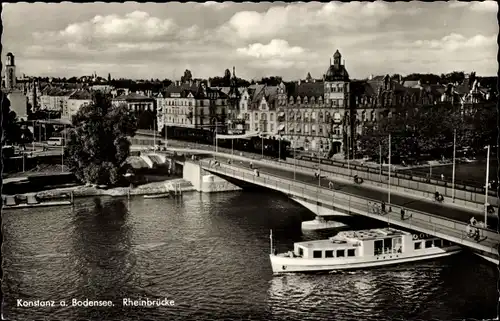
{"left": 203, "top": 164, "right": 500, "bottom": 250}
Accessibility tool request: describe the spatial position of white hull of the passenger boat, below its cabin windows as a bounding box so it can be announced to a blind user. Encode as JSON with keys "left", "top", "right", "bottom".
{"left": 270, "top": 246, "right": 461, "bottom": 274}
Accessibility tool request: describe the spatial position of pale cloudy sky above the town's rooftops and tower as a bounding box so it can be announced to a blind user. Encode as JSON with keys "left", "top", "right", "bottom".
{"left": 2, "top": 1, "right": 499, "bottom": 80}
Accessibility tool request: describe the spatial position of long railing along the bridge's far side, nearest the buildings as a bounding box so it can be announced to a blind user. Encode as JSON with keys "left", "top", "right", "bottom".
{"left": 134, "top": 135, "right": 498, "bottom": 210}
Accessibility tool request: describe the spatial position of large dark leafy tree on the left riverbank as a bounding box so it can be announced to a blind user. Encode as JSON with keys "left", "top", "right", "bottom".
{"left": 64, "top": 92, "right": 136, "bottom": 185}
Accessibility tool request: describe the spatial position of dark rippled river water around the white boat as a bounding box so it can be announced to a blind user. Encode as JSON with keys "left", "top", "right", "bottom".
{"left": 2, "top": 191, "right": 498, "bottom": 321}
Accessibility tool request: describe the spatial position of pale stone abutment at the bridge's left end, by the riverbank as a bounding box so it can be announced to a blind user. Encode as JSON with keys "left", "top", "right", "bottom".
{"left": 182, "top": 160, "right": 241, "bottom": 193}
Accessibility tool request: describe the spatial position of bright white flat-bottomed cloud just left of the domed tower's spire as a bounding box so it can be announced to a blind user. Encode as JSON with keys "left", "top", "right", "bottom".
{"left": 236, "top": 39, "right": 305, "bottom": 59}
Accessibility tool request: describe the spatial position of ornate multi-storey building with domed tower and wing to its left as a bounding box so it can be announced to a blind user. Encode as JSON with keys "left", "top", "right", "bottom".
{"left": 284, "top": 50, "right": 352, "bottom": 156}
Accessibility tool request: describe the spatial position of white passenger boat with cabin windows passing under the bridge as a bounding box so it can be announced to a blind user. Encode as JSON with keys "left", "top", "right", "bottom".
{"left": 270, "top": 227, "right": 461, "bottom": 273}
